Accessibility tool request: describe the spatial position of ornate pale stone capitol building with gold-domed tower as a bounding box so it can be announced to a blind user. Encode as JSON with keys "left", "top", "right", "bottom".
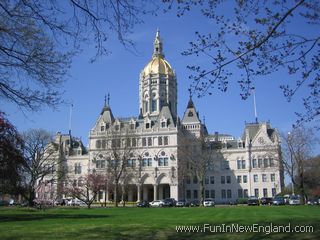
{"left": 45, "top": 31, "right": 284, "bottom": 203}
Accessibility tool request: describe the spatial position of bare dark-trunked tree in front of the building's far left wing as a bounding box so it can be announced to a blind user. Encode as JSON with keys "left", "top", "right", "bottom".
{"left": 19, "top": 129, "right": 64, "bottom": 206}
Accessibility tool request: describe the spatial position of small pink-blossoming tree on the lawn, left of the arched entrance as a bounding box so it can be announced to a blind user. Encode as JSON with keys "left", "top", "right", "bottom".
{"left": 64, "top": 173, "right": 106, "bottom": 208}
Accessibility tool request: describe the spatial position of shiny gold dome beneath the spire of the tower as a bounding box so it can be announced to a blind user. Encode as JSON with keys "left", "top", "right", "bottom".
{"left": 142, "top": 56, "right": 174, "bottom": 75}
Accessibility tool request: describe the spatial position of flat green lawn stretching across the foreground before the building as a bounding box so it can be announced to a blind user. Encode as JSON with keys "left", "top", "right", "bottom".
{"left": 0, "top": 206, "right": 320, "bottom": 240}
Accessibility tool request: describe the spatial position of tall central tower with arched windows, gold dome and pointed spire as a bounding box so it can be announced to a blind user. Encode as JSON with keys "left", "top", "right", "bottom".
{"left": 139, "top": 30, "right": 177, "bottom": 119}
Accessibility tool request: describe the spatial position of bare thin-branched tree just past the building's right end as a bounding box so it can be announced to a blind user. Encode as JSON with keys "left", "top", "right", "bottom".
{"left": 281, "top": 127, "right": 317, "bottom": 201}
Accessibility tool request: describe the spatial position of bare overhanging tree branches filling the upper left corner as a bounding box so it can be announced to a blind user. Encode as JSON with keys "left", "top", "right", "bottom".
{"left": 0, "top": 0, "right": 154, "bottom": 111}
